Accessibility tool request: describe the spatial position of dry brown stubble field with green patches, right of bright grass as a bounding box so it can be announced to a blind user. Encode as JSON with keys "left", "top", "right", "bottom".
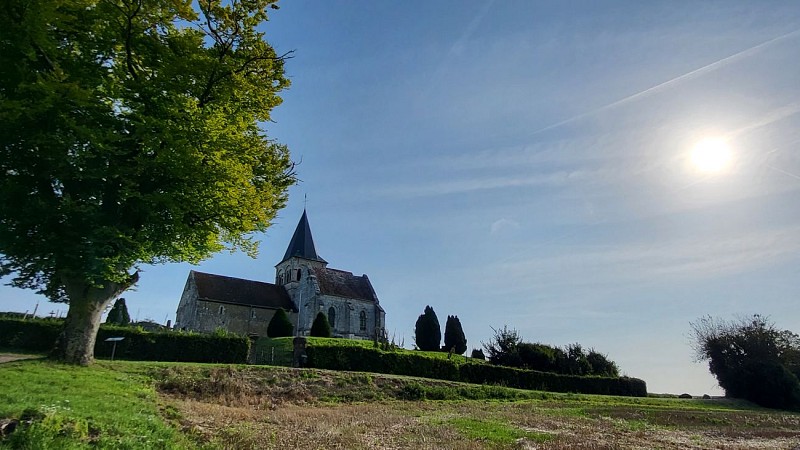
{"left": 153, "top": 371, "right": 800, "bottom": 450}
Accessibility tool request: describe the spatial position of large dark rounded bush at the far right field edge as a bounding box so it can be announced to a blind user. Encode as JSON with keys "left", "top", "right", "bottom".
{"left": 691, "top": 314, "right": 800, "bottom": 409}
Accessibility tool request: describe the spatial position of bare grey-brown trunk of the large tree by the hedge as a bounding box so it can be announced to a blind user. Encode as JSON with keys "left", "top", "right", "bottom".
{"left": 50, "top": 273, "right": 139, "bottom": 366}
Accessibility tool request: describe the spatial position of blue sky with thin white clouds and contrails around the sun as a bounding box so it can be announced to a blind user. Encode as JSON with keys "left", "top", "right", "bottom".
{"left": 0, "top": 1, "right": 800, "bottom": 394}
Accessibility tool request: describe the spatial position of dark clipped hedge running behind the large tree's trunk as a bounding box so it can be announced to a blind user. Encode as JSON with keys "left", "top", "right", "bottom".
{"left": 0, "top": 318, "right": 250, "bottom": 364}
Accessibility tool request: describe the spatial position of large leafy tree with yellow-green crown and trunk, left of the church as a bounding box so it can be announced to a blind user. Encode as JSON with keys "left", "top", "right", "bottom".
{"left": 0, "top": 0, "right": 295, "bottom": 364}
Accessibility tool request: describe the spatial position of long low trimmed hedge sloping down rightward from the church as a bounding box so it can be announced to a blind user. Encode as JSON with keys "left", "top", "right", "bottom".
{"left": 306, "top": 344, "right": 647, "bottom": 397}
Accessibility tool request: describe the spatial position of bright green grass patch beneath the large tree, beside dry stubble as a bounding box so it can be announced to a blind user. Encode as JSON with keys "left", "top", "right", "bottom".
{"left": 0, "top": 359, "right": 198, "bottom": 448}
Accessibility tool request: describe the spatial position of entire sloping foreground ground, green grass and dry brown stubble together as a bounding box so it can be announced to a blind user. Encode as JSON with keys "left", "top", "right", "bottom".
{"left": 0, "top": 354, "right": 800, "bottom": 449}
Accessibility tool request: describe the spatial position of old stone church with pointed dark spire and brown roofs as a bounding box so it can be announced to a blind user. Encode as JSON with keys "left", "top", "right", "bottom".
{"left": 175, "top": 210, "right": 386, "bottom": 339}
